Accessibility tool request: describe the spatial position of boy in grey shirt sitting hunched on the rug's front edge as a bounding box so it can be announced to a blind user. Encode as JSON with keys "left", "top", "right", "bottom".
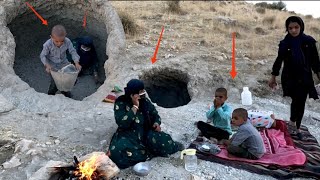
{"left": 224, "top": 108, "right": 265, "bottom": 160}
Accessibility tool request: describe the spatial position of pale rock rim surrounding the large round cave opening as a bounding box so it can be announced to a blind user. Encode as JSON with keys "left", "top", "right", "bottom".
{"left": 0, "top": 0, "right": 126, "bottom": 111}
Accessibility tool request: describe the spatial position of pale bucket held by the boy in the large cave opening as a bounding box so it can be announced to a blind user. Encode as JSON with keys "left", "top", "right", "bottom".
{"left": 50, "top": 64, "right": 79, "bottom": 92}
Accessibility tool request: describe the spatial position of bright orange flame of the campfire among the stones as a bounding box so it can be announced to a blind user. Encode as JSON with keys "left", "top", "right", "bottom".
{"left": 76, "top": 154, "right": 99, "bottom": 180}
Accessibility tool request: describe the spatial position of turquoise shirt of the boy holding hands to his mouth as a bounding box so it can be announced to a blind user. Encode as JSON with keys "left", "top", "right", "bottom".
{"left": 206, "top": 103, "right": 232, "bottom": 134}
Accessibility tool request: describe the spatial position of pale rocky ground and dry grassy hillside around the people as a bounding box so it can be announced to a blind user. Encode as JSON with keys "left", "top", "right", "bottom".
{"left": 0, "top": 0, "right": 320, "bottom": 180}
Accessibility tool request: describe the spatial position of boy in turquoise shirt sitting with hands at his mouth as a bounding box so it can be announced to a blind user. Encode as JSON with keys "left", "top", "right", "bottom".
{"left": 196, "top": 88, "right": 232, "bottom": 141}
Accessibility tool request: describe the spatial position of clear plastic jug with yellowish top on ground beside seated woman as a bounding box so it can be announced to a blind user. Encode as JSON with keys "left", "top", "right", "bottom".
{"left": 181, "top": 149, "right": 198, "bottom": 172}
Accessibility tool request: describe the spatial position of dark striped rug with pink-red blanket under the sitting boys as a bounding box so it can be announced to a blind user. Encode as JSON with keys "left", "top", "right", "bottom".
{"left": 189, "top": 120, "right": 320, "bottom": 179}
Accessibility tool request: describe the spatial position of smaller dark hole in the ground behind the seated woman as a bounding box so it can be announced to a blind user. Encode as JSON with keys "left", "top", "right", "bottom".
{"left": 140, "top": 69, "right": 191, "bottom": 108}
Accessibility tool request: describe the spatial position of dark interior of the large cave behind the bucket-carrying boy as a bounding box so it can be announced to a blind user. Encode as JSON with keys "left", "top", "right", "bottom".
{"left": 8, "top": 4, "right": 108, "bottom": 100}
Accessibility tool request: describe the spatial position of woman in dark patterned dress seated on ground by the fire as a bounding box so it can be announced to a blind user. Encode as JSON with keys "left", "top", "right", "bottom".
{"left": 108, "top": 79, "right": 184, "bottom": 169}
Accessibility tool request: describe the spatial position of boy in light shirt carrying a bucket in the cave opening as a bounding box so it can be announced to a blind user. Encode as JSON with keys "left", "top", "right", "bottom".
{"left": 40, "top": 25, "right": 81, "bottom": 97}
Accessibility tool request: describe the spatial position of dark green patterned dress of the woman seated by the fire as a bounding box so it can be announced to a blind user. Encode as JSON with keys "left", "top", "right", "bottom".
{"left": 109, "top": 97, "right": 178, "bottom": 169}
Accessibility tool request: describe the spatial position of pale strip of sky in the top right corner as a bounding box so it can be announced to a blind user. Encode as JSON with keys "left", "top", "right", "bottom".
{"left": 247, "top": 1, "right": 320, "bottom": 18}
